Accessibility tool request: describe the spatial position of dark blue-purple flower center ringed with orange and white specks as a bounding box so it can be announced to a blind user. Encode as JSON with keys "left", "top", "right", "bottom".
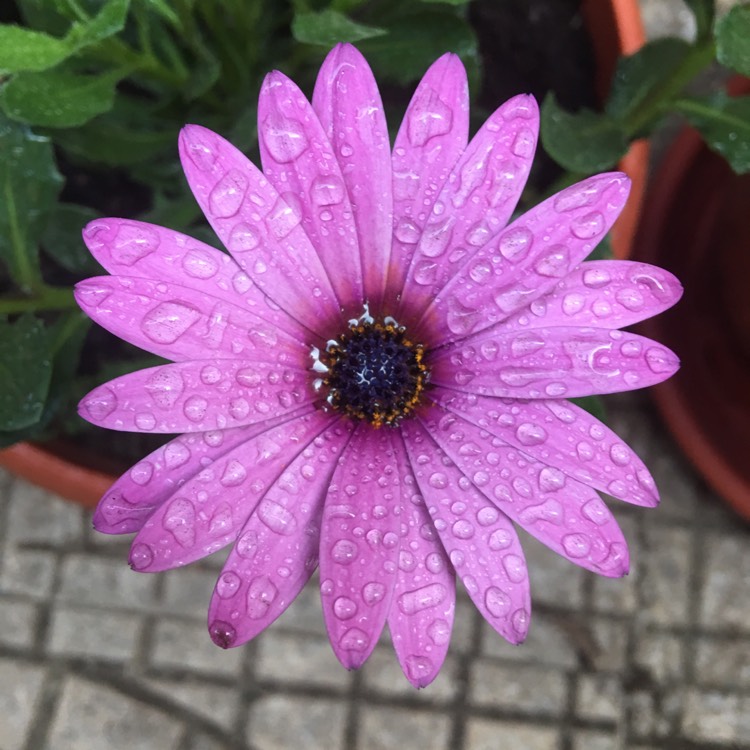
{"left": 312, "top": 309, "right": 430, "bottom": 427}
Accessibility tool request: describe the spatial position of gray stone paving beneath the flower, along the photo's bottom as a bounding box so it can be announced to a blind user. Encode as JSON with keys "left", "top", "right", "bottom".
{"left": 0, "top": 396, "right": 750, "bottom": 750}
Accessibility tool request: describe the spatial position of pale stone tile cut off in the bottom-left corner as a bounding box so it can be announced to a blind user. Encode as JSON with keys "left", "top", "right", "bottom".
{"left": 0, "top": 659, "right": 45, "bottom": 750}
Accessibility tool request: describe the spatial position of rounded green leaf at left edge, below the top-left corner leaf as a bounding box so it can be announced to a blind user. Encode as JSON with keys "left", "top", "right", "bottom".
{"left": 0, "top": 70, "right": 125, "bottom": 128}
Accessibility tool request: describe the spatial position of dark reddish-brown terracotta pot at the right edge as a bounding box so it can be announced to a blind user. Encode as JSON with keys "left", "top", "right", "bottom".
{"left": 637, "top": 80, "right": 750, "bottom": 519}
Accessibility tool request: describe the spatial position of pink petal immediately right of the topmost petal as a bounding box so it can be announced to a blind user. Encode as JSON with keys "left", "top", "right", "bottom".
{"left": 388, "top": 53, "right": 469, "bottom": 300}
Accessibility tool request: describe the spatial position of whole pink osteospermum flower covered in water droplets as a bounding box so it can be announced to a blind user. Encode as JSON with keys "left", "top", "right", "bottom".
{"left": 76, "top": 45, "right": 681, "bottom": 686}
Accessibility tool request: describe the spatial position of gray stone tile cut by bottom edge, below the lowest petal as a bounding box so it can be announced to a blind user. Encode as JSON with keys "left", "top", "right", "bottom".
{"left": 357, "top": 706, "right": 451, "bottom": 750}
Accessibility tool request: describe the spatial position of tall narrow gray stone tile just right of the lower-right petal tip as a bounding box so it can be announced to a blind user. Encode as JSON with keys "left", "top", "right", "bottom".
{"left": 642, "top": 525, "right": 693, "bottom": 625}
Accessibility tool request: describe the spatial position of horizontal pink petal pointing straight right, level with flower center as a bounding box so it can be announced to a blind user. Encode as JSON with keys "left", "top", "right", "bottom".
{"left": 431, "top": 327, "right": 680, "bottom": 398}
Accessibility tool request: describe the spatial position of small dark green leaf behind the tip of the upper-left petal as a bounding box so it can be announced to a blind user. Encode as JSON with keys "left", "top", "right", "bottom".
{"left": 41, "top": 203, "right": 106, "bottom": 276}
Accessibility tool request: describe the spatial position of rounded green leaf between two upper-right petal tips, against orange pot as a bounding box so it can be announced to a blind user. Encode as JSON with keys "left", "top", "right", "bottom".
{"left": 541, "top": 92, "right": 628, "bottom": 174}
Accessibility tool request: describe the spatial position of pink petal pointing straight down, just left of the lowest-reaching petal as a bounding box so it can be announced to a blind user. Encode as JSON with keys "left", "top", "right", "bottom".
{"left": 320, "top": 425, "right": 401, "bottom": 669}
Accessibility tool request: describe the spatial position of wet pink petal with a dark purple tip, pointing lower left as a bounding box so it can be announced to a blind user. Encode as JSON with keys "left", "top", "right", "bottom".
{"left": 208, "top": 421, "right": 353, "bottom": 648}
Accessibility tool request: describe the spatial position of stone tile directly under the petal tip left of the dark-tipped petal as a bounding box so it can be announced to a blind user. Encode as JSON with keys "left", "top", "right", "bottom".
{"left": 58, "top": 554, "right": 156, "bottom": 610}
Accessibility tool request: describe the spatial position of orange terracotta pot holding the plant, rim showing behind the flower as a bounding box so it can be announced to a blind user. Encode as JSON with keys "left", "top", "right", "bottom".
{"left": 0, "top": 0, "right": 649, "bottom": 508}
